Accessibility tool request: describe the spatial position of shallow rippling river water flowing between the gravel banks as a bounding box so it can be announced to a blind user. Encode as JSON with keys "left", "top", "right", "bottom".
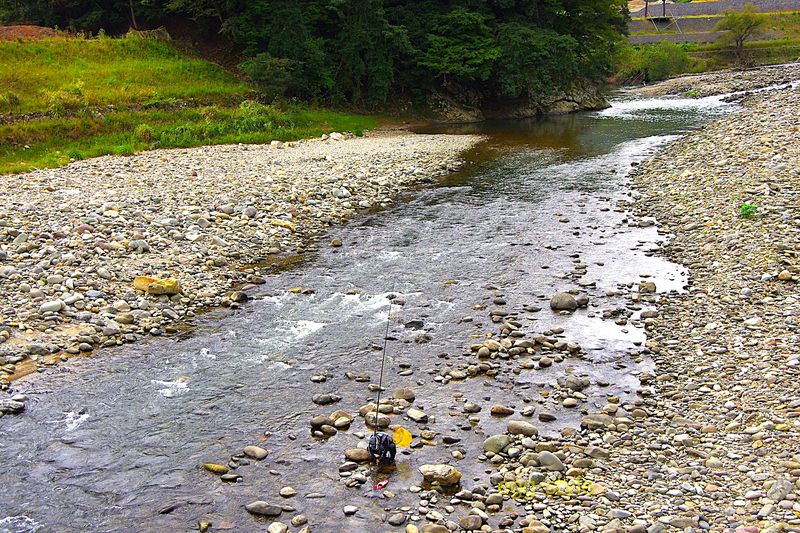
{"left": 0, "top": 95, "right": 736, "bottom": 532}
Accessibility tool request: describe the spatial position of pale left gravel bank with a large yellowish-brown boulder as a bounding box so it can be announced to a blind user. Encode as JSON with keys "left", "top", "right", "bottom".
{"left": 0, "top": 133, "right": 479, "bottom": 390}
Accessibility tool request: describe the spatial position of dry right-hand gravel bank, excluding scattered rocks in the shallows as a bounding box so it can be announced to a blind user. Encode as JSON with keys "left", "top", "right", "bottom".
{"left": 446, "top": 86, "right": 800, "bottom": 533}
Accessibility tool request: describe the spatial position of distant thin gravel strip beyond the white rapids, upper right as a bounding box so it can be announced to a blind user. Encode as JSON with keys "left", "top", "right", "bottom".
{"left": 633, "top": 63, "right": 800, "bottom": 97}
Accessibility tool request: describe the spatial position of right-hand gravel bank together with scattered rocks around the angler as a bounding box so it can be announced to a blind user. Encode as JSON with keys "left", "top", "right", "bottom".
{"left": 195, "top": 80, "right": 800, "bottom": 533}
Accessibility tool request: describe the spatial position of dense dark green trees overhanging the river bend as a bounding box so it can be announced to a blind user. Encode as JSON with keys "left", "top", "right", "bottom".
{"left": 0, "top": 0, "right": 627, "bottom": 105}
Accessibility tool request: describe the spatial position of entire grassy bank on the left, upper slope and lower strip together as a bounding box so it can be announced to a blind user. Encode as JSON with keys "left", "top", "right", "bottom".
{"left": 0, "top": 36, "right": 376, "bottom": 173}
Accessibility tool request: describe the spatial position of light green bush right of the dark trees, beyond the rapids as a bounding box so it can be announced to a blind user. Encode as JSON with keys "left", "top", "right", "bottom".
{"left": 615, "top": 41, "right": 692, "bottom": 83}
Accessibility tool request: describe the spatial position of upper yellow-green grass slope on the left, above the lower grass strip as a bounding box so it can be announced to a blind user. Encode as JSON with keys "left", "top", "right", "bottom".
{"left": 0, "top": 35, "right": 251, "bottom": 113}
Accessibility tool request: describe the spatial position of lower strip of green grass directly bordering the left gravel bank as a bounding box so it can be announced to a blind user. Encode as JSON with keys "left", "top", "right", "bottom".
{"left": 0, "top": 102, "right": 377, "bottom": 174}
